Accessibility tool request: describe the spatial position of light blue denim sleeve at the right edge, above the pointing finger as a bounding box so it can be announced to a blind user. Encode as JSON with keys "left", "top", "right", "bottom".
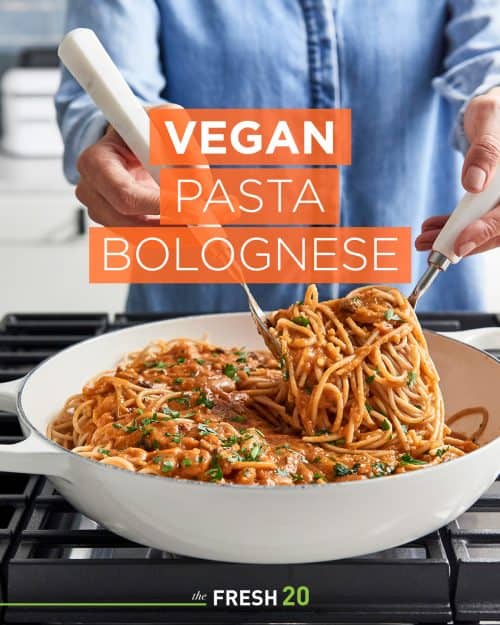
{"left": 433, "top": 0, "right": 500, "bottom": 153}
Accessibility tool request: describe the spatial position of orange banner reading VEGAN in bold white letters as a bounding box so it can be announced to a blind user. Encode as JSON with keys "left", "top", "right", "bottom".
{"left": 149, "top": 107, "right": 351, "bottom": 166}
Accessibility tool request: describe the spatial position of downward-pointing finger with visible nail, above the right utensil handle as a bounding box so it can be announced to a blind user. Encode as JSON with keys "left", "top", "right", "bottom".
{"left": 462, "top": 90, "right": 500, "bottom": 193}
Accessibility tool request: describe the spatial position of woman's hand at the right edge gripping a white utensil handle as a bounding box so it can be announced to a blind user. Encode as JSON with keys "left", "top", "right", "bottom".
{"left": 415, "top": 87, "right": 500, "bottom": 256}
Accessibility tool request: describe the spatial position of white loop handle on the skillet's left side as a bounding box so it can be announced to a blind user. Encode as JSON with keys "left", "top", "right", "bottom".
{"left": 0, "top": 379, "right": 70, "bottom": 477}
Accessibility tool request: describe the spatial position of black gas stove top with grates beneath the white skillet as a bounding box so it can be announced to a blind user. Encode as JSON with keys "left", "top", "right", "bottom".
{"left": 0, "top": 313, "right": 500, "bottom": 623}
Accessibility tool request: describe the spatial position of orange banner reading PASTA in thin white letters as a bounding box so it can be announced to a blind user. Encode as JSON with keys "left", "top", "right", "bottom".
{"left": 161, "top": 167, "right": 339, "bottom": 226}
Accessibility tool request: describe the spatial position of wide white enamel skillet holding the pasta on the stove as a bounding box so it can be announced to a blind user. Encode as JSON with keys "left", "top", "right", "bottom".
{"left": 0, "top": 313, "right": 500, "bottom": 563}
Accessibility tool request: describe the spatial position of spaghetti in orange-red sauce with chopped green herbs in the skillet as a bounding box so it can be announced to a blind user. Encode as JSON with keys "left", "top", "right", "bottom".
{"left": 48, "top": 286, "right": 487, "bottom": 485}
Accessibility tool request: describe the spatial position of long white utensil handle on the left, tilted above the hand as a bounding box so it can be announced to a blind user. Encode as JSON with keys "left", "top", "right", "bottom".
{"left": 58, "top": 28, "right": 160, "bottom": 183}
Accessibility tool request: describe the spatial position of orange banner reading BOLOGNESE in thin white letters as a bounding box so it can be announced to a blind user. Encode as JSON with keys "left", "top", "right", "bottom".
{"left": 90, "top": 226, "right": 411, "bottom": 283}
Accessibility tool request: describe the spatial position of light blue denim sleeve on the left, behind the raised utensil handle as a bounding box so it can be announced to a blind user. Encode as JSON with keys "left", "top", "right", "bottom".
{"left": 55, "top": 0, "right": 165, "bottom": 183}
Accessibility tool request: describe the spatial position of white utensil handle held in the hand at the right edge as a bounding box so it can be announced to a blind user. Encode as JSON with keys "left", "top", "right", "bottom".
{"left": 432, "top": 166, "right": 500, "bottom": 263}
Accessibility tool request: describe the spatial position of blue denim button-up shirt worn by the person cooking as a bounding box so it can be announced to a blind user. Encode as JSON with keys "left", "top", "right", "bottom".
{"left": 56, "top": 0, "right": 500, "bottom": 313}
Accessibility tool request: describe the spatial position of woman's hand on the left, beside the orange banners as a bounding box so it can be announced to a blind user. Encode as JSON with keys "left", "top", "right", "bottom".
{"left": 75, "top": 126, "right": 160, "bottom": 226}
